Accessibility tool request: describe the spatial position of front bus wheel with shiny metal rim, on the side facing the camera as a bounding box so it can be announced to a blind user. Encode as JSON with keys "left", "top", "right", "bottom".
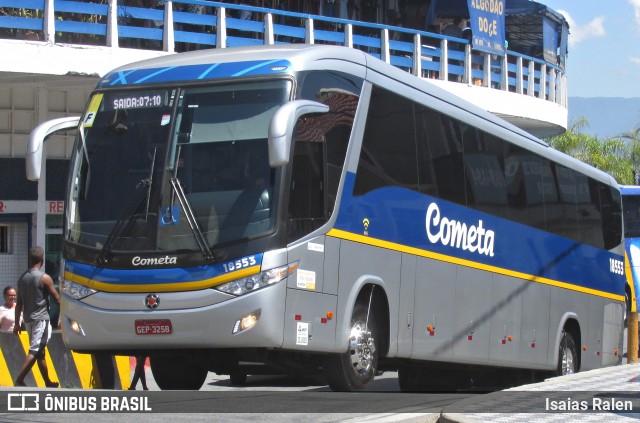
{"left": 324, "top": 302, "right": 380, "bottom": 391}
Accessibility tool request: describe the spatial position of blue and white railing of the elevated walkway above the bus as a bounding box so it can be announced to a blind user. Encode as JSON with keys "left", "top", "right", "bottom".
{"left": 0, "top": 0, "right": 567, "bottom": 108}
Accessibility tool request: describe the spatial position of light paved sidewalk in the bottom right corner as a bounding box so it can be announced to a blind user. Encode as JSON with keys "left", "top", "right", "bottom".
{"left": 438, "top": 364, "right": 640, "bottom": 423}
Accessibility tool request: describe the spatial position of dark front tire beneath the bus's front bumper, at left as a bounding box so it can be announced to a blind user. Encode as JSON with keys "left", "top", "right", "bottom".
{"left": 149, "top": 354, "right": 209, "bottom": 391}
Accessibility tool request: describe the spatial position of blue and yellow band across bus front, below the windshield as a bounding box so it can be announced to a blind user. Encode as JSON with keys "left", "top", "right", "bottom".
{"left": 65, "top": 253, "right": 263, "bottom": 291}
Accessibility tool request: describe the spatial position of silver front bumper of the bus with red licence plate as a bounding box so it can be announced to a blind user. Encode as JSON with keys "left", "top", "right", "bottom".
{"left": 61, "top": 280, "right": 286, "bottom": 351}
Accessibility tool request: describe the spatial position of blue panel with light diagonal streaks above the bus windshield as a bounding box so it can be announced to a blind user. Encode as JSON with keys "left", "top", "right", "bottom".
{"left": 98, "top": 60, "right": 291, "bottom": 88}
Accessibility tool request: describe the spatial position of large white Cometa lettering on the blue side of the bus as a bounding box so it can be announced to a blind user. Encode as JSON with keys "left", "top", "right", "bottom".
{"left": 426, "top": 203, "right": 495, "bottom": 257}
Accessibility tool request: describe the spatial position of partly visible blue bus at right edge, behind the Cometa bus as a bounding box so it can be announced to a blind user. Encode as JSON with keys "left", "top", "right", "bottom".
{"left": 620, "top": 185, "right": 640, "bottom": 326}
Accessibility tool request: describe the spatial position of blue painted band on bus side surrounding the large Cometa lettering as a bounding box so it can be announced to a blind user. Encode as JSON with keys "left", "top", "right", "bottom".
{"left": 335, "top": 173, "right": 625, "bottom": 298}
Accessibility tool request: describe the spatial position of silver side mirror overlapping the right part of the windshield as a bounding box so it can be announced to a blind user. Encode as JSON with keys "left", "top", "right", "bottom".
{"left": 269, "top": 100, "right": 329, "bottom": 167}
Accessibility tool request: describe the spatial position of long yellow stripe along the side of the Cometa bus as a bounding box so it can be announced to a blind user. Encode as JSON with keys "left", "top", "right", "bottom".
{"left": 327, "top": 229, "right": 624, "bottom": 301}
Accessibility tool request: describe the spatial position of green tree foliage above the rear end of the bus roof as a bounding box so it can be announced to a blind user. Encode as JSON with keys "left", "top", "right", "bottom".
{"left": 547, "top": 118, "right": 640, "bottom": 185}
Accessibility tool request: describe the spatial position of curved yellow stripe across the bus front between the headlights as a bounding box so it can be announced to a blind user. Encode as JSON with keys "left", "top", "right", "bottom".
{"left": 64, "top": 266, "right": 260, "bottom": 292}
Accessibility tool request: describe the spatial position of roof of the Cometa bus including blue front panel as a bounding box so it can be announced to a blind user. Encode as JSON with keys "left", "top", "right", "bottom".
{"left": 97, "top": 44, "right": 617, "bottom": 189}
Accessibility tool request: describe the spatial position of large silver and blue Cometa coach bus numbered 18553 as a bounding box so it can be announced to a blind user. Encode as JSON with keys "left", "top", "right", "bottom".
{"left": 27, "top": 45, "right": 625, "bottom": 391}
